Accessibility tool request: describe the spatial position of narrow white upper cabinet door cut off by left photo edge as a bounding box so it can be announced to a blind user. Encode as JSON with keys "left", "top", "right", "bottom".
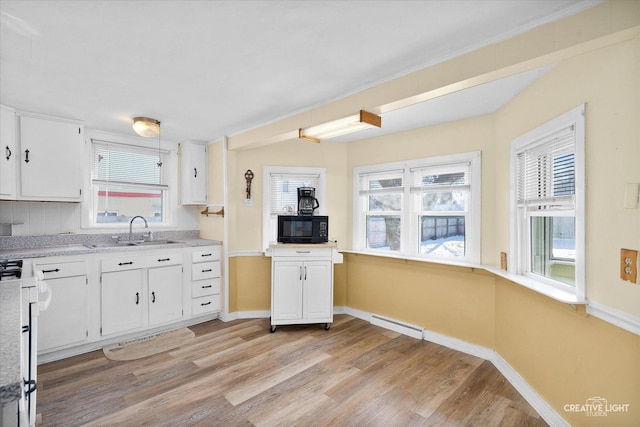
{"left": 0, "top": 106, "right": 18, "bottom": 200}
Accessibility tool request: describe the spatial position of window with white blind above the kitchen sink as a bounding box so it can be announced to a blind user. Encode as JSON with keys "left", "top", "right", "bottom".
{"left": 91, "top": 140, "right": 169, "bottom": 226}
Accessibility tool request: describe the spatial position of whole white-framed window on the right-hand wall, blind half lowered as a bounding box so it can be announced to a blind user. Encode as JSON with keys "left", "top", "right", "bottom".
{"left": 510, "top": 105, "right": 584, "bottom": 297}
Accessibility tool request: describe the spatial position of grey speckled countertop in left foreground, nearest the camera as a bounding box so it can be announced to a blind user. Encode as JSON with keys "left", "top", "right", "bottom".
{"left": 0, "top": 281, "right": 22, "bottom": 406}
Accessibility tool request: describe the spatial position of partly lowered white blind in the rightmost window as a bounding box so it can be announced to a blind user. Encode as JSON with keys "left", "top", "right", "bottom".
{"left": 516, "top": 125, "right": 575, "bottom": 208}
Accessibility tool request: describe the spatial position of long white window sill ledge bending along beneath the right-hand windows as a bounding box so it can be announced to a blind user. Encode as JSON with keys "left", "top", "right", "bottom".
{"left": 339, "top": 250, "right": 587, "bottom": 305}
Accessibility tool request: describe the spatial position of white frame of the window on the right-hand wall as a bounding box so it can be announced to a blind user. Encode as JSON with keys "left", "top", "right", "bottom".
{"left": 508, "top": 104, "right": 585, "bottom": 300}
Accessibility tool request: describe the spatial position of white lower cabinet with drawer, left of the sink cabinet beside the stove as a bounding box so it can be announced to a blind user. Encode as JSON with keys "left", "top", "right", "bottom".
{"left": 36, "top": 261, "right": 89, "bottom": 351}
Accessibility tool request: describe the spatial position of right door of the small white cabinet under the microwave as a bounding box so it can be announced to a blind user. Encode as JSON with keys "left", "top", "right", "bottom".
{"left": 303, "top": 261, "right": 333, "bottom": 319}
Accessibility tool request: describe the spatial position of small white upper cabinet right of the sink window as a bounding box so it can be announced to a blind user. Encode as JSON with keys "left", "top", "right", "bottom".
{"left": 180, "top": 141, "right": 208, "bottom": 205}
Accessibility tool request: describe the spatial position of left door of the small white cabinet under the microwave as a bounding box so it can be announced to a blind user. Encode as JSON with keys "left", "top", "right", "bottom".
{"left": 271, "top": 261, "right": 303, "bottom": 320}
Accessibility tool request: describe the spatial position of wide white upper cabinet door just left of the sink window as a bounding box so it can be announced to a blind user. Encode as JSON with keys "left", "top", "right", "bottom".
{"left": 20, "top": 116, "right": 83, "bottom": 201}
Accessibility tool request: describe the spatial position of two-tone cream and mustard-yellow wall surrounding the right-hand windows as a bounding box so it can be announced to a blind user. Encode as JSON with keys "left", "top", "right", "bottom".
{"left": 201, "top": 1, "right": 640, "bottom": 426}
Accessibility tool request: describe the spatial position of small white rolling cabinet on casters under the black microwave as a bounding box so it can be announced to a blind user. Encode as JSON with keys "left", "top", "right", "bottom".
{"left": 271, "top": 248, "right": 333, "bottom": 332}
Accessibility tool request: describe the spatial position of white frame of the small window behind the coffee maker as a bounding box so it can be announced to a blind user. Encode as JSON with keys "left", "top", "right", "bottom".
{"left": 262, "top": 166, "right": 327, "bottom": 252}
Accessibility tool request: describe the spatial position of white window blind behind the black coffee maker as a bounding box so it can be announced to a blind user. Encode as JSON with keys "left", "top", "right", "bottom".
{"left": 269, "top": 173, "right": 322, "bottom": 215}
